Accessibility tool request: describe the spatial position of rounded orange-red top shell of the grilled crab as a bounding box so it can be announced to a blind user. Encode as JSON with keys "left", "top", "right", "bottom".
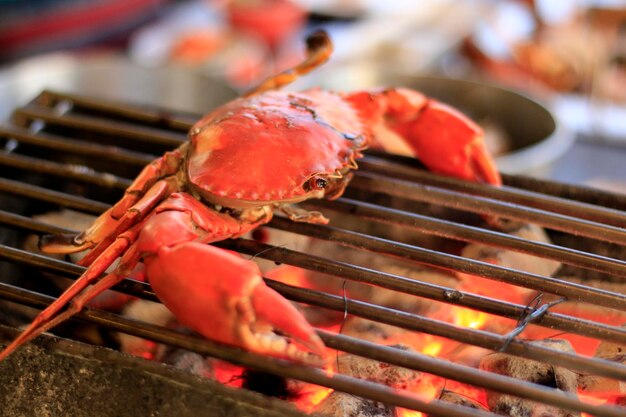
{"left": 187, "top": 89, "right": 367, "bottom": 207}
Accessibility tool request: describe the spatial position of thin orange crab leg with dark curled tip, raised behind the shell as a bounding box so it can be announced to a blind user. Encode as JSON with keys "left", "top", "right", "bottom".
{"left": 243, "top": 30, "right": 333, "bottom": 97}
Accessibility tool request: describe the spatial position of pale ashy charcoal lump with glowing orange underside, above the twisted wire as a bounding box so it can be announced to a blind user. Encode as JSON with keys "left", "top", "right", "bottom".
{"left": 458, "top": 224, "right": 561, "bottom": 304}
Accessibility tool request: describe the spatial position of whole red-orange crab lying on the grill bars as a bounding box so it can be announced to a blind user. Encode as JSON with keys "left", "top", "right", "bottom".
{"left": 0, "top": 32, "right": 500, "bottom": 361}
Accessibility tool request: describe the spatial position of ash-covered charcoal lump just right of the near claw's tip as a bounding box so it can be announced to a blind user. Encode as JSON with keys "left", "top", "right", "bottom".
{"left": 337, "top": 345, "right": 422, "bottom": 390}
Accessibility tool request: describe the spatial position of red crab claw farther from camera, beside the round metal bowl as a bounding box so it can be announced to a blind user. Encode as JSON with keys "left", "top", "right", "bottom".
{"left": 345, "top": 88, "right": 502, "bottom": 185}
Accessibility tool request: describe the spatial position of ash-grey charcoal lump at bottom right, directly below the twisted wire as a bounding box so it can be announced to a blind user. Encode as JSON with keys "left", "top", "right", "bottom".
{"left": 480, "top": 339, "right": 580, "bottom": 417}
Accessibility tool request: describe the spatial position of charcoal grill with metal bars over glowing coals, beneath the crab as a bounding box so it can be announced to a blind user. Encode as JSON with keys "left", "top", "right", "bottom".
{"left": 0, "top": 91, "right": 626, "bottom": 417}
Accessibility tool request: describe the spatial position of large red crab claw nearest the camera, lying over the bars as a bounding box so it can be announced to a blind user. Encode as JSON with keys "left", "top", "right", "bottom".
{"left": 146, "top": 242, "right": 324, "bottom": 365}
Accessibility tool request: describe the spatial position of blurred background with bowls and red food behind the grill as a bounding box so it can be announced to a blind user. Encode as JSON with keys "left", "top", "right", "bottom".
{"left": 0, "top": 0, "right": 626, "bottom": 192}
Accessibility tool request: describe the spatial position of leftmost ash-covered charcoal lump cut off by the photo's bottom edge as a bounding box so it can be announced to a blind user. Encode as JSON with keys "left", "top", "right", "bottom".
{"left": 315, "top": 391, "right": 396, "bottom": 417}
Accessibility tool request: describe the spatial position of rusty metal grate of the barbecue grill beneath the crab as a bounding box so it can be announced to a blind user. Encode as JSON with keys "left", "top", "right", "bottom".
{"left": 0, "top": 91, "right": 626, "bottom": 416}
